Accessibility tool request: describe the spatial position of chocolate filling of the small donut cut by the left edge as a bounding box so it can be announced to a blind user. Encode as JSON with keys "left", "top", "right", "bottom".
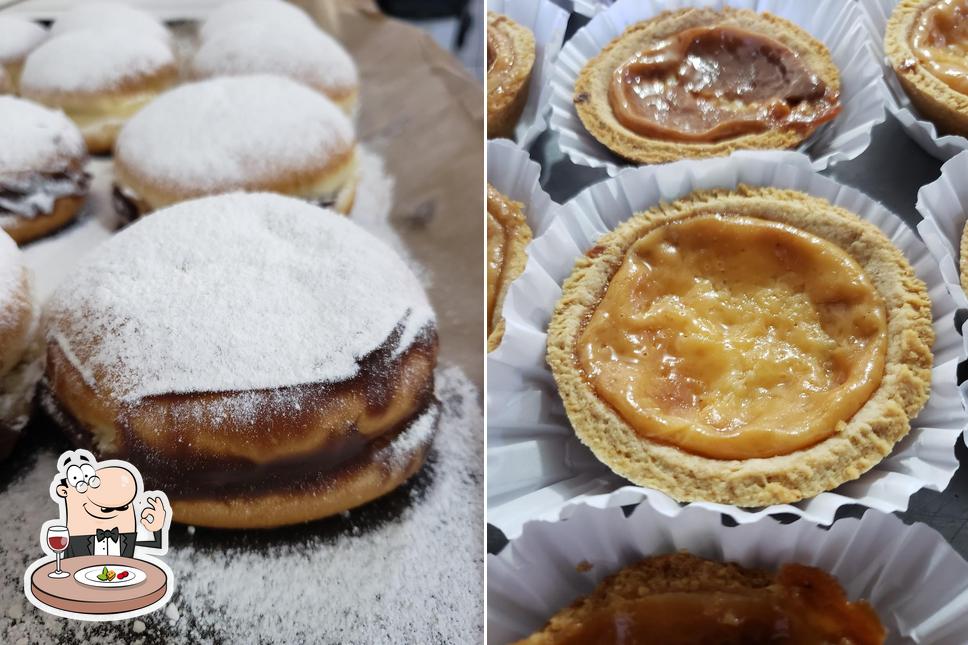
{"left": 0, "top": 166, "right": 91, "bottom": 218}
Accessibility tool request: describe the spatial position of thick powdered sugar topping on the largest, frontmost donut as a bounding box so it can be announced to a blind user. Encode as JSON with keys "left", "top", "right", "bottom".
{"left": 47, "top": 193, "right": 434, "bottom": 401}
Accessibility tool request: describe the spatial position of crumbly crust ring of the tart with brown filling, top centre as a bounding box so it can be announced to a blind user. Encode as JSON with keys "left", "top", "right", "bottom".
{"left": 574, "top": 7, "right": 840, "bottom": 164}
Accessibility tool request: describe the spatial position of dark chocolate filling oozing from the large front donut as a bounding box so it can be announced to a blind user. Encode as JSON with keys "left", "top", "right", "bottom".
{"left": 39, "top": 325, "right": 440, "bottom": 499}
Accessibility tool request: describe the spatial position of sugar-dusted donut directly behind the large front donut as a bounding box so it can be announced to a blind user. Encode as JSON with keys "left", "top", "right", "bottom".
{"left": 114, "top": 76, "right": 358, "bottom": 217}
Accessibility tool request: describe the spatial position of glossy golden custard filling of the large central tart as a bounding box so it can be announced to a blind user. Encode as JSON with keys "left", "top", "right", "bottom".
{"left": 576, "top": 213, "right": 887, "bottom": 459}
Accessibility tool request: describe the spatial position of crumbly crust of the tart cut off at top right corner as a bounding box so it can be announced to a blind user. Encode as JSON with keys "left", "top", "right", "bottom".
{"left": 884, "top": 0, "right": 968, "bottom": 135}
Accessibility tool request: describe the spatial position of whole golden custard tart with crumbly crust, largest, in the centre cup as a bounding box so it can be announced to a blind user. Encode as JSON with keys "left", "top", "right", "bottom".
{"left": 548, "top": 187, "right": 934, "bottom": 507}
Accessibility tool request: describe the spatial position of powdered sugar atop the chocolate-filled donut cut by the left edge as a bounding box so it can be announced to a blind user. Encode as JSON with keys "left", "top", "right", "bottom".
{"left": 0, "top": 96, "right": 86, "bottom": 174}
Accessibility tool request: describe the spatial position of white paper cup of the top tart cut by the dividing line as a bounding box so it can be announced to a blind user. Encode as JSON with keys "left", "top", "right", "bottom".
{"left": 487, "top": 0, "right": 568, "bottom": 148}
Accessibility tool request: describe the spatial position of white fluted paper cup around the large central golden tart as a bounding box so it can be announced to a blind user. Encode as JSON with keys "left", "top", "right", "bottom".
{"left": 487, "top": 151, "right": 968, "bottom": 537}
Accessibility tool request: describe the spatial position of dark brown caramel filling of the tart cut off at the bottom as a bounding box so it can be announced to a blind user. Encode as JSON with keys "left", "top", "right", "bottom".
{"left": 555, "top": 564, "right": 885, "bottom": 645}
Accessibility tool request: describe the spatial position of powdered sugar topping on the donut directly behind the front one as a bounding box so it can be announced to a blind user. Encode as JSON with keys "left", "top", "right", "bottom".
{"left": 115, "top": 76, "right": 355, "bottom": 194}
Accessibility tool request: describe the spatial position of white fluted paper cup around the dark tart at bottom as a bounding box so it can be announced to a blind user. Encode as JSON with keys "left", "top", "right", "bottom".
{"left": 487, "top": 504, "right": 968, "bottom": 645}
